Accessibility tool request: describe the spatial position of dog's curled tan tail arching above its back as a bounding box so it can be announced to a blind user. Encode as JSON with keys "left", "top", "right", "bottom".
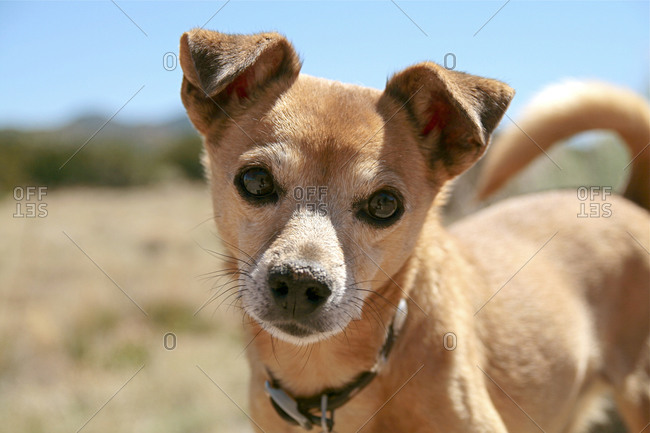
{"left": 478, "top": 81, "right": 650, "bottom": 210}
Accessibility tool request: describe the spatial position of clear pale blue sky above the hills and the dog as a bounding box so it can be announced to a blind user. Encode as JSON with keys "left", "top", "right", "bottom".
{"left": 0, "top": 0, "right": 650, "bottom": 128}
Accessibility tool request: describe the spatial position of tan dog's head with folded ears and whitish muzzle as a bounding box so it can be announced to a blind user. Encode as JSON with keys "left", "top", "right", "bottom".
{"left": 180, "top": 30, "right": 513, "bottom": 343}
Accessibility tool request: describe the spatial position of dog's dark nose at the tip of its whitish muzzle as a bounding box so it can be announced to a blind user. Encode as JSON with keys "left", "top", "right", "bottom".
{"left": 269, "top": 265, "right": 332, "bottom": 319}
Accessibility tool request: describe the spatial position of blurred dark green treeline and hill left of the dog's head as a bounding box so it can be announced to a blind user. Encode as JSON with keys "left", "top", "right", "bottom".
{"left": 0, "top": 115, "right": 203, "bottom": 192}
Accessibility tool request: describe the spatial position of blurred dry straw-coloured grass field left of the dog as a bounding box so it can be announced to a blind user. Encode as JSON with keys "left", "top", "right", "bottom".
{"left": 0, "top": 184, "right": 250, "bottom": 433}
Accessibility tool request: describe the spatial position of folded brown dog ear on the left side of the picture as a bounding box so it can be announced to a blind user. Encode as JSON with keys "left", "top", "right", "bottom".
{"left": 180, "top": 29, "right": 300, "bottom": 134}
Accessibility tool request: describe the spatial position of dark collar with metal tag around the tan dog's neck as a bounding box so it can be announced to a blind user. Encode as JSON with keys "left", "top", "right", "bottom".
{"left": 264, "top": 299, "right": 408, "bottom": 432}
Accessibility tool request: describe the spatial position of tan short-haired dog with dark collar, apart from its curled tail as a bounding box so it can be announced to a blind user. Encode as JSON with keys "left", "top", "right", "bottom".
{"left": 180, "top": 30, "right": 650, "bottom": 433}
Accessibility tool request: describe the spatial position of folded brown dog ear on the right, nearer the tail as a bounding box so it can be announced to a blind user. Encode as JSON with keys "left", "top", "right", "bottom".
{"left": 383, "top": 62, "right": 515, "bottom": 179}
